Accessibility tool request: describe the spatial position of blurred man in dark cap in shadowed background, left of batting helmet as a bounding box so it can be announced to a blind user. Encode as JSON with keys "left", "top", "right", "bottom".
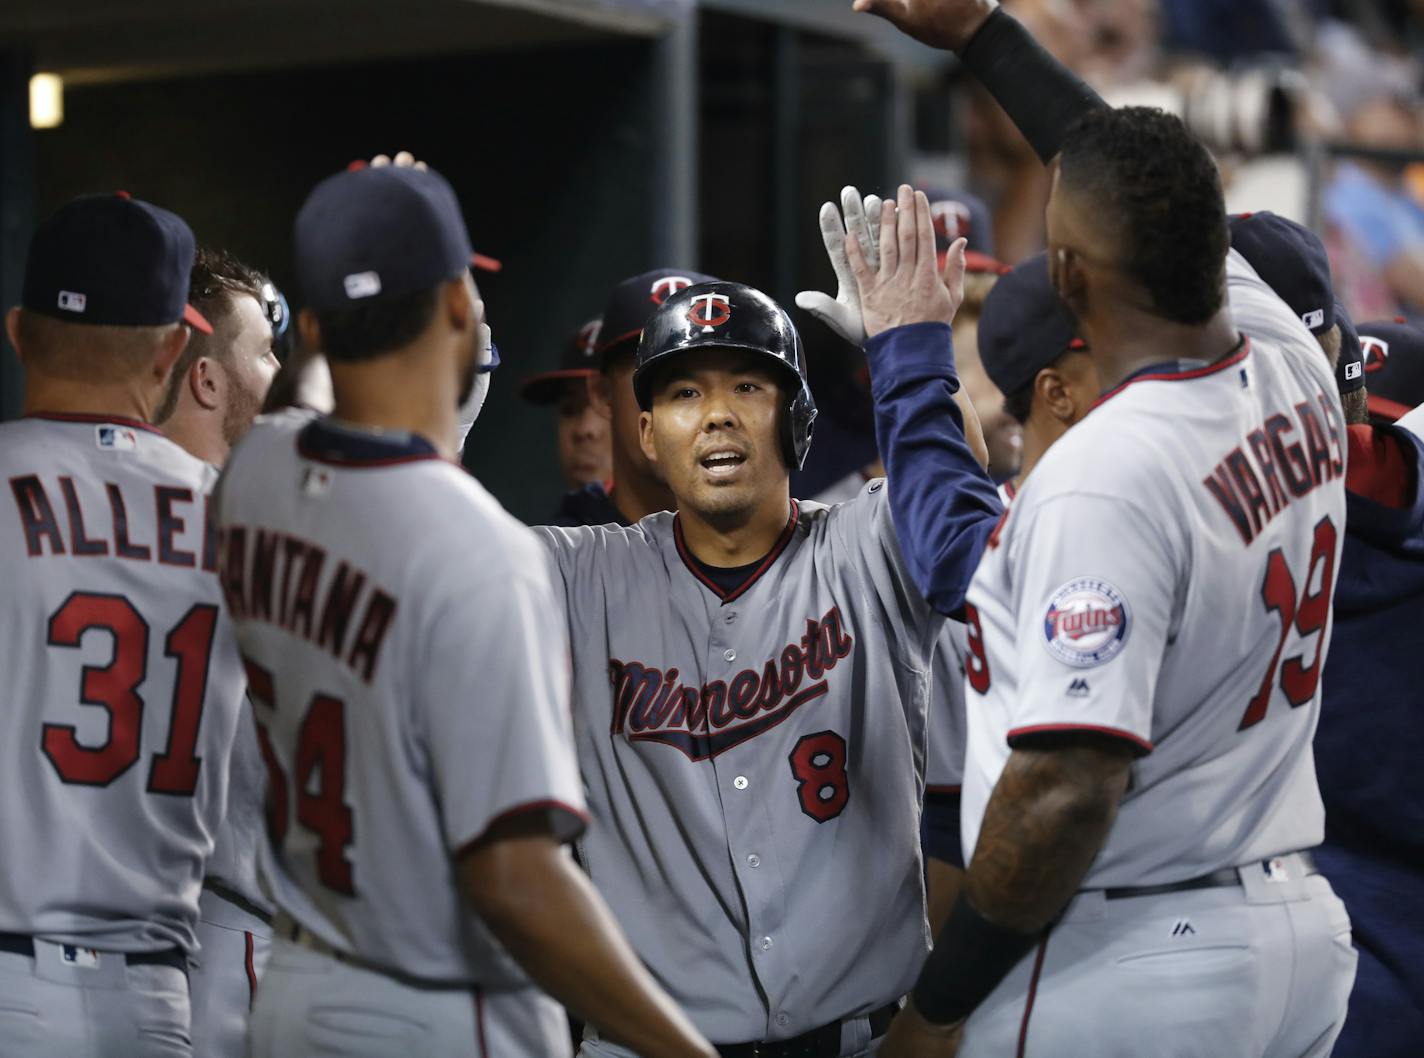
{"left": 520, "top": 319, "right": 612, "bottom": 488}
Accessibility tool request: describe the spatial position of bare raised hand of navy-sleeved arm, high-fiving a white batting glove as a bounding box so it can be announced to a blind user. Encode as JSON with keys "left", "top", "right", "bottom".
{"left": 846, "top": 184, "right": 967, "bottom": 337}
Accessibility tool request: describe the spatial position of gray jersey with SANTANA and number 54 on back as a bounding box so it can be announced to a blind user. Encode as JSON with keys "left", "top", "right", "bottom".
{"left": 216, "top": 412, "right": 584, "bottom": 988}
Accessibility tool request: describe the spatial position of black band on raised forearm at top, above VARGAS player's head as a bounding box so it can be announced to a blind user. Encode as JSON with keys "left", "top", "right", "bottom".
{"left": 960, "top": 7, "right": 1108, "bottom": 165}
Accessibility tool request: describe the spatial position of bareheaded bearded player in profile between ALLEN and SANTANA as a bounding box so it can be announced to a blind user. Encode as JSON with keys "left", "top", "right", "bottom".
{"left": 159, "top": 246, "right": 281, "bottom": 1058}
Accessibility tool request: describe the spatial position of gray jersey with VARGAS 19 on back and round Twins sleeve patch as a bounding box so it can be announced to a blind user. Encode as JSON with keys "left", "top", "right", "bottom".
{"left": 963, "top": 253, "right": 1346, "bottom": 889}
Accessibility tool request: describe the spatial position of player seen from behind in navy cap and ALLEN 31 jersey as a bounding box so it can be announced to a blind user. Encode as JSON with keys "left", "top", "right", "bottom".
{"left": 0, "top": 194, "right": 242, "bottom": 1058}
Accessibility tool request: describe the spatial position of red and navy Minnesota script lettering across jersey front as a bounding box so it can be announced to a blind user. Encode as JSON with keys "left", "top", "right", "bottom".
{"left": 608, "top": 607, "right": 854, "bottom": 760}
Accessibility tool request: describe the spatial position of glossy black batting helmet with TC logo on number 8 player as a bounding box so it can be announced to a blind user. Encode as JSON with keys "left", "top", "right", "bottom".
{"left": 632, "top": 281, "right": 816, "bottom": 470}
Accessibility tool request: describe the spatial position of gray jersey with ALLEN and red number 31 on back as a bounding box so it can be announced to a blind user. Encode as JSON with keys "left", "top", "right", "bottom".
{"left": 0, "top": 416, "right": 244, "bottom": 951}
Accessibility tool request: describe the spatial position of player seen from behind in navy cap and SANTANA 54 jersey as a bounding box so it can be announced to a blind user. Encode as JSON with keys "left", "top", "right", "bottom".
{"left": 218, "top": 165, "right": 712, "bottom": 1058}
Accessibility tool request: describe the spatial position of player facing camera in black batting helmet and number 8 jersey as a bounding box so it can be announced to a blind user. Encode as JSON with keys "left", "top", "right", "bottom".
{"left": 537, "top": 259, "right": 998, "bottom": 1058}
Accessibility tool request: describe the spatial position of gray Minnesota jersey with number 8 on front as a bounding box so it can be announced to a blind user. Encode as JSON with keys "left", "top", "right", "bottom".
{"left": 538, "top": 480, "right": 943, "bottom": 1042}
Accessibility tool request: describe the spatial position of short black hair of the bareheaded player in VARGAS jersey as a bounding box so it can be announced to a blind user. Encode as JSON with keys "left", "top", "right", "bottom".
{"left": 1059, "top": 107, "right": 1230, "bottom": 323}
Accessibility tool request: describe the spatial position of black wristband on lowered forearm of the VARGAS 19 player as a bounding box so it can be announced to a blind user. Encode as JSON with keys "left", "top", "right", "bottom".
{"left": 911, "top": 893, "right": 1038, "bottom": 1025}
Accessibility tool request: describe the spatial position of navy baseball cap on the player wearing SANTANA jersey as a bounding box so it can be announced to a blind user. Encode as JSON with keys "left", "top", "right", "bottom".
{"left": 293, "top": 165, "right": 477, "bottom": 312}
